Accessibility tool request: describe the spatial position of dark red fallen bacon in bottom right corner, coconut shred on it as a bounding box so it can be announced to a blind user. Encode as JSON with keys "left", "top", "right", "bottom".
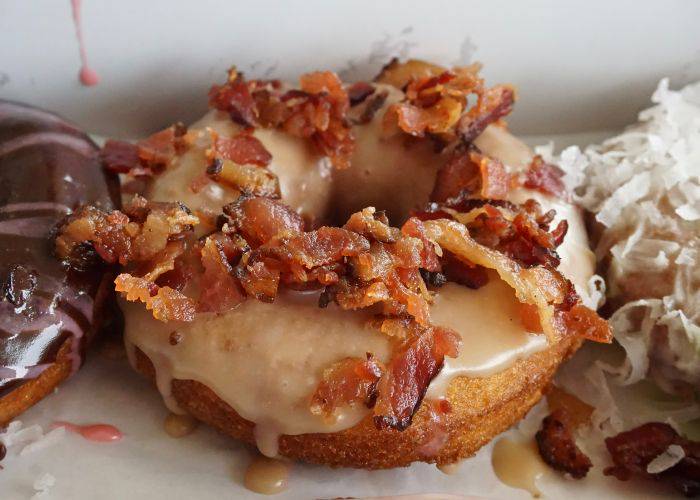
{"left": 604, "top": 422, "right": 700, "bottom": 497}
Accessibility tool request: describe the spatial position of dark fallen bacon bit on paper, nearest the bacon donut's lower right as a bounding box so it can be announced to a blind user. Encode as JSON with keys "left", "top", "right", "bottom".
{"left": 535, "top": 412, "right": 593, "bottom": 479}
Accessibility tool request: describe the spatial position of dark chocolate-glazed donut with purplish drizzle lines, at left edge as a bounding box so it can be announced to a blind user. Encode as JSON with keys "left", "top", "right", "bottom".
{"left": 0, "top": 100, "right": 119, "bottom": 425}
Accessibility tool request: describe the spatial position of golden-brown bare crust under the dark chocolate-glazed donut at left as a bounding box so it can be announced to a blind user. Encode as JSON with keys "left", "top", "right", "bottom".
{"left": 0, "top": 338, "right": 73, "bottom": 427}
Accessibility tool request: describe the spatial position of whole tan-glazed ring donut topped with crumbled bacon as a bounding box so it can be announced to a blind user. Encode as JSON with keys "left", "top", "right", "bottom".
{"left": 57, "top": 61, "right": 609, "bottom": 468}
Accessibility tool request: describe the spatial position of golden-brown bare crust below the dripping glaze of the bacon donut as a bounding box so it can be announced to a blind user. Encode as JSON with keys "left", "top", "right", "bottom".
{"left": 136, "top": 337, "right": 581, "bottom": 469}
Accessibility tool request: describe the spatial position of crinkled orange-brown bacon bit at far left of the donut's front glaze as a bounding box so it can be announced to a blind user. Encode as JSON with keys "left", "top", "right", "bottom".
{"left": 114, "top": 274, "right": 195, "bottom": 322}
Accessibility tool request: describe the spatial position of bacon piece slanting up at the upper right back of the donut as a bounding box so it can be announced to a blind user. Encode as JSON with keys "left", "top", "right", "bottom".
{"left": 457, "top": 85, "right": 515, "bottom": 143}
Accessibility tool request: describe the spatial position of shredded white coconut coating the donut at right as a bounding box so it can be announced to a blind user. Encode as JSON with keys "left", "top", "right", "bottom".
{"left": 537, "top": 79, "right": 700, "bottom": 391}
